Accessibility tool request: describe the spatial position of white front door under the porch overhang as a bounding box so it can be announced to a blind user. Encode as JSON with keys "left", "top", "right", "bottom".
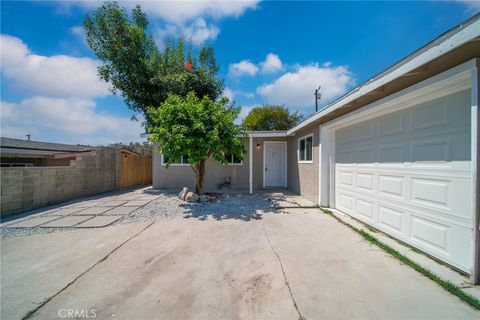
{"left": 263, "top": 141, "right": 287, "bottom": 187}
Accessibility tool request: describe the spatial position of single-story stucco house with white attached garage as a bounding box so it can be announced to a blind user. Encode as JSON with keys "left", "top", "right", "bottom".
{"left": 153, "top": 14, "right": 480, "bottom": 283}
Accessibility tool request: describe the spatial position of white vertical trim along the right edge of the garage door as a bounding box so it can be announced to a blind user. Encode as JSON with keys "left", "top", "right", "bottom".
{"left": 470, "top": 59, "right": 480, "bottom": 284}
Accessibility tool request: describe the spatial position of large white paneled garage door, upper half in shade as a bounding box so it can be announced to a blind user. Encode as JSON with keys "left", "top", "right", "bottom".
{"left": 335, "top": 90, "right": 472, "bottom": 272}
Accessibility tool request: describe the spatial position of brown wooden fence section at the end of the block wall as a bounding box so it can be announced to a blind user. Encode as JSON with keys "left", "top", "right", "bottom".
{"left": 120, "top": 150, "right": 152, "bottom": 188}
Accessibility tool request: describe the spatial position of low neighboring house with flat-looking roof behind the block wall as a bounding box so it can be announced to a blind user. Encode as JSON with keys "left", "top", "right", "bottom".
{"left": 0, "top": 137, "right": 93, "bottom": 167}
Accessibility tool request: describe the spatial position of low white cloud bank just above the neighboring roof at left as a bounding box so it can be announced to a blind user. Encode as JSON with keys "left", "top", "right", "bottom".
{"left": 0, "top": 96, "right": 143, "bottom": 145}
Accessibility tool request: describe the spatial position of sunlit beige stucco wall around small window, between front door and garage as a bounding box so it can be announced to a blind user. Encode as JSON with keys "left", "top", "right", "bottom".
{"left": 287, "top": 124, "right": 319, "bottom": 203}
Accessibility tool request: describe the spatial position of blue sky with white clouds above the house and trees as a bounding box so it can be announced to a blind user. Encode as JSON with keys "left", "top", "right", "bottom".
{"left": 1, "top": 1, "right": 480, "bottom": 144}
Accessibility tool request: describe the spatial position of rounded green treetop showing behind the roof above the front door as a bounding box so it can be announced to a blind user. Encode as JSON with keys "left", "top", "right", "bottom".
{"left": 243, "top": 105, "right": 303, "bottom": 131}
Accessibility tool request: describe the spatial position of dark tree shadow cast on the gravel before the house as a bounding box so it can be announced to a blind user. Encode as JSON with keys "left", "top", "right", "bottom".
{"left": 180, "top": 194, "right": 279, "bottom": 221}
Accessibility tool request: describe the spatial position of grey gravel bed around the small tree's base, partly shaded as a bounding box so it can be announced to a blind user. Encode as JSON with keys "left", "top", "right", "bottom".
{"left": 117, "top": 192, "right": 275, "bottom": 223}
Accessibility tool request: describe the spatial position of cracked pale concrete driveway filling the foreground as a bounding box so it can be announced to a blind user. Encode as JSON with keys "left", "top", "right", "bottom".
{"left": 1, "top": 208, "right": 480, "bottom": 319}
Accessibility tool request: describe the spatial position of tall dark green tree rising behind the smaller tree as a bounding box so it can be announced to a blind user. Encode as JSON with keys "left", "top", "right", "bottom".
{"left": 83, "top": 2, "right": 224, "bottom": 126}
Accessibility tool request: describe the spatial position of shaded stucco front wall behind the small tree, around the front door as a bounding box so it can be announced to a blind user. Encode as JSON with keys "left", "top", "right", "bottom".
{"left": 152, "top": 138, "right": 288, "bottom": 191}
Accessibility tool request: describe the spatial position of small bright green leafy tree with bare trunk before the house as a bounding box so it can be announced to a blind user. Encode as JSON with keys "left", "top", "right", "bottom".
{"left": 148, "top": 92, "right": 245, "bottom": 195}
